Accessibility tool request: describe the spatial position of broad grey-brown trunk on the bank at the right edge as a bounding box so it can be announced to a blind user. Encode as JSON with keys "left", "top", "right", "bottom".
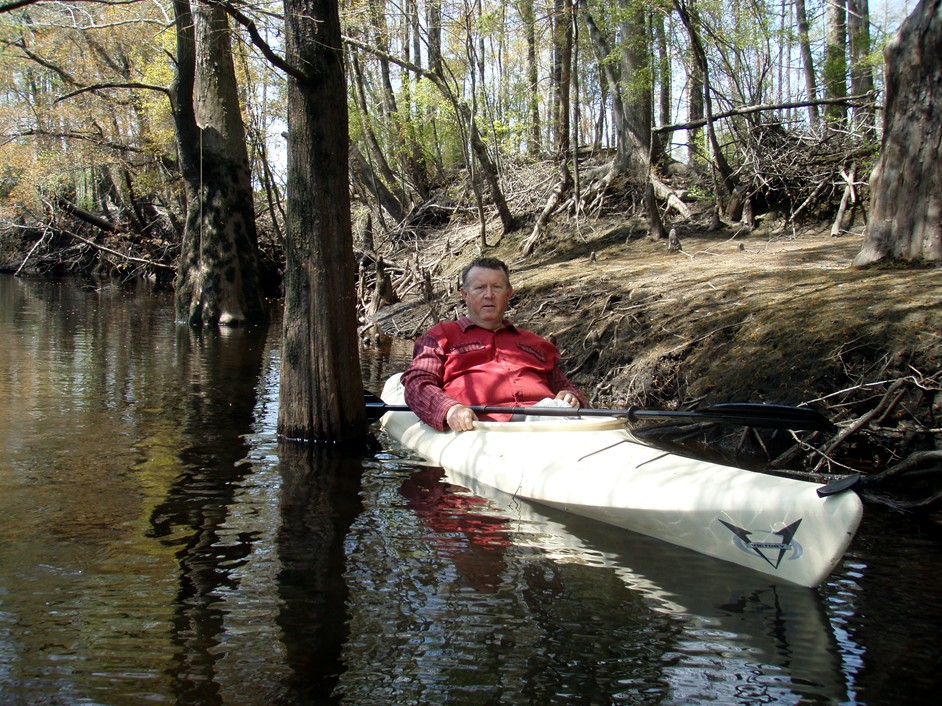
{"left": 854, "top": 0, "right": 942, "bottom": 266}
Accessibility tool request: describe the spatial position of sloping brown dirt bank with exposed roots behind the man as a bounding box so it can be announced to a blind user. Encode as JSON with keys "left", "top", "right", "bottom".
{"left": 380, "top": 201, "right": 942, "bottom": 508}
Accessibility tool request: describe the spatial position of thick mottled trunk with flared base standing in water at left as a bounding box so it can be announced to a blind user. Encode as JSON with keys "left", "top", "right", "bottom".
{"left": 175, "top": 0, "right": 265, "bottom": 326}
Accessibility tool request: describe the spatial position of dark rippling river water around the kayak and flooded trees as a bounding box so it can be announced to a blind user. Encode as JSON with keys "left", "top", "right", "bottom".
{"left": 0, "top": 276, "right": 942, "bottom": 704}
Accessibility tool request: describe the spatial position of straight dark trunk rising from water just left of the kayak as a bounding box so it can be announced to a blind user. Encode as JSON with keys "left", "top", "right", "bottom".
{"left": 278, "top": 0, "right": 366, "bottom": 442}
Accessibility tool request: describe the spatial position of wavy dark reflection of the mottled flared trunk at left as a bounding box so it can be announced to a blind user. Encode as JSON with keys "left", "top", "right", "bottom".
{"left": 151, "top": 327, "right": 267, "bottom": 704}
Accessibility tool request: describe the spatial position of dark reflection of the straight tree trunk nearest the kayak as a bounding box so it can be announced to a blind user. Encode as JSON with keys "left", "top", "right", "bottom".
{"left": 277, "top": 443, "right": 363, "bottom": 703}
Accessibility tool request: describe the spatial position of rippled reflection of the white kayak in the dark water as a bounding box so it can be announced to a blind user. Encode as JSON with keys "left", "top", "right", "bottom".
{"left": 434, "top": 469, "right": 847, "bottom": 703}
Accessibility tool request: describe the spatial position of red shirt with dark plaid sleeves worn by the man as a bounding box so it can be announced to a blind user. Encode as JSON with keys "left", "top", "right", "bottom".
{"left": 402, "top": 316, "right": 586, "bottom": 431}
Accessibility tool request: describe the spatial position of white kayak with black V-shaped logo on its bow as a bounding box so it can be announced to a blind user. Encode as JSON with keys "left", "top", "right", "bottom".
{"left": 382, "top": 375, "right": 863, "bottom": 586}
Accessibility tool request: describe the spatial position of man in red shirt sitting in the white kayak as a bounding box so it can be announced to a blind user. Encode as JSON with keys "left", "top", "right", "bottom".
{"left": 402, "top": 257, "right": 587, "bottom": 431}
